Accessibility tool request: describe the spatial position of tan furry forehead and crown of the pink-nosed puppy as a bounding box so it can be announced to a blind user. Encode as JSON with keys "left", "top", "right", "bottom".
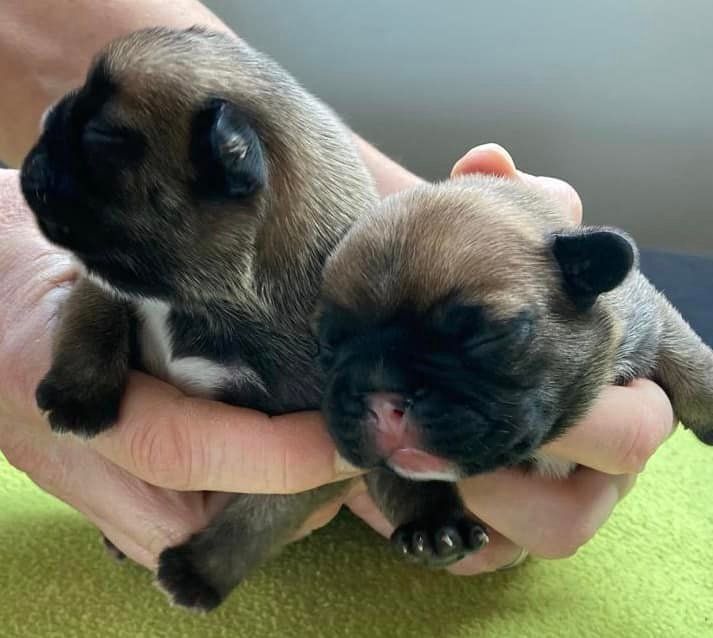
{"left": 323, "top": 180, "right": 565, "bottom": 317}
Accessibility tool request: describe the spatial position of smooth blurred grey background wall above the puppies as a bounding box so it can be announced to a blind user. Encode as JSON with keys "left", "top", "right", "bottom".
{"left": 205, "top": 0, "right": 713, "bottom": 255}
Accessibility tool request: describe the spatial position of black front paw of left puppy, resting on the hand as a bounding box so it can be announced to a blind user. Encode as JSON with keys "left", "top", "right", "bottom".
{"left": 35, "top": 371, "right": 123, "bottom": 438}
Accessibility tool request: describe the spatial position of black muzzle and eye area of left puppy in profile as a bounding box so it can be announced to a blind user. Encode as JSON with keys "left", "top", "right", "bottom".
{"left": 21, "top": 73, "right": 141, "bottom": 258}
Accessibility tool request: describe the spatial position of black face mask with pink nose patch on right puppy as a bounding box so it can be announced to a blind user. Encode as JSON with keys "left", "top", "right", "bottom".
{"left": 321, "top": 300, "right": 552, "bottom": 480}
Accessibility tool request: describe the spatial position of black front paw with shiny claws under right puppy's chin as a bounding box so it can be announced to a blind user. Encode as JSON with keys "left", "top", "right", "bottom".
{"left": 391, "top": 514, "right": 488, "bottom": 568}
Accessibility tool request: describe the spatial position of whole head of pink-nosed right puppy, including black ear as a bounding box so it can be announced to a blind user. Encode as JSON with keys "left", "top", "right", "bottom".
{"left": 317, "top": 179, "right": 634, "bottom": 480}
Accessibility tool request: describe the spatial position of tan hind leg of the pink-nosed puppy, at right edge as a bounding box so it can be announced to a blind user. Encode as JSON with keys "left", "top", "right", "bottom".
{"left": 654, "top": 293, "right": 713, "bottom": 445}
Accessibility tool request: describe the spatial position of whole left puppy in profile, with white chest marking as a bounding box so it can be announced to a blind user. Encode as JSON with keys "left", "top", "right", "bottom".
{"left": 21, "top": 28, "right": 376, "bottom": 610}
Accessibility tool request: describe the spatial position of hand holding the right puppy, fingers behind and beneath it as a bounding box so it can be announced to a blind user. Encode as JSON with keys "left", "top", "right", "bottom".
{"left": 347, "top": 144, "right": 674, "bottom": 574}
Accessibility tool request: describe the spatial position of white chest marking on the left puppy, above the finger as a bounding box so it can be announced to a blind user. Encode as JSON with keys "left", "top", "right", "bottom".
{"left": 137, "top": 300, "right": 232, "bottom": 399}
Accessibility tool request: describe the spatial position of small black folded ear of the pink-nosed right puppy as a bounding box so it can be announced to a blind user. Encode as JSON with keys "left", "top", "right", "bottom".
{"left": 552, "top": 228, "right": 637, "bottom": 310}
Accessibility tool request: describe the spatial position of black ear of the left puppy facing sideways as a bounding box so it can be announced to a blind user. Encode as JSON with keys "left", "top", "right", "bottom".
{"left": 190, "top": 99, "right": 267, "bottom": 198}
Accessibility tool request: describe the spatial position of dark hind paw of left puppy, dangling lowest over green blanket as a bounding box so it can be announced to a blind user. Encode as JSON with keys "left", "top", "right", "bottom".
{"left": 156, "top": 545, "right": 222, "bottom": 612}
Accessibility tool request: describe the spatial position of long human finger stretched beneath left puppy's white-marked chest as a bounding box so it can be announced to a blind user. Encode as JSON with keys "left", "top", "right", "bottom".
{"left": 89, "top": 373, "right": 358, "bottom": 493}
